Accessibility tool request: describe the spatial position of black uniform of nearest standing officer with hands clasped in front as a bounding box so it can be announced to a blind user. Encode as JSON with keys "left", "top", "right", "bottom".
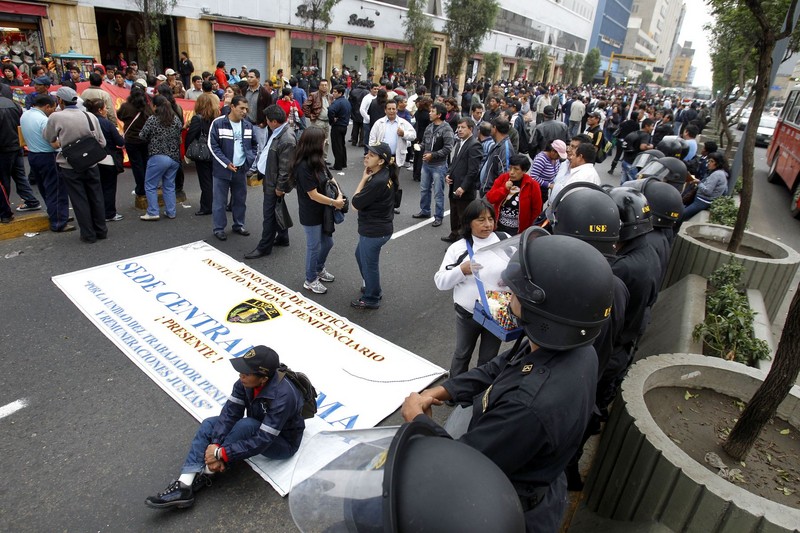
{"left": 415, "top": 345, "right": 597, "bottom": 532}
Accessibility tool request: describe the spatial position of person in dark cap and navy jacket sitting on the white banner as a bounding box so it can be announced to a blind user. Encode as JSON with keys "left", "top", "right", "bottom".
{"left": 144, "top": 346, "right": 306, "bottom": 509}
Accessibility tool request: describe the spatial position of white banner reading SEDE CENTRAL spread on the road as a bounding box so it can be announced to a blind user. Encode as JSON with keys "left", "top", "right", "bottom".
{"left": 53, "top": 241, "right": 445, "bottom": 495}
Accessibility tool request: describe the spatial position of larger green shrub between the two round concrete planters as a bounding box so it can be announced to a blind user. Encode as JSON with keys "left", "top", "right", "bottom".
{"left": 692, "top": 261, "right": 769, "bottom": 365}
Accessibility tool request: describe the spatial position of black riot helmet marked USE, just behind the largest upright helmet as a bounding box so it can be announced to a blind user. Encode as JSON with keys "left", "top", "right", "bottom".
{"left": 552, "top": 182, "right": 622, "bottom": 254}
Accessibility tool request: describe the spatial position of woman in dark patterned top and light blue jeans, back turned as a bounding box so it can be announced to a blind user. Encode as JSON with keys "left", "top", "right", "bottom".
{"left": 139, "top": 95, "right": 181, "bottom": 220}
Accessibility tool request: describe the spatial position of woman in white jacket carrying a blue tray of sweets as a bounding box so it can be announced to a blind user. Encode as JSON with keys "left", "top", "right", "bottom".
{"left": 433, "top": 198, "right": 505, "bottom": 378}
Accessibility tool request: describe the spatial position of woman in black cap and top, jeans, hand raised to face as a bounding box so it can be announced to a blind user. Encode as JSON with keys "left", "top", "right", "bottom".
{"left": 350, "top": 143, "right": 397, "bottom": 309}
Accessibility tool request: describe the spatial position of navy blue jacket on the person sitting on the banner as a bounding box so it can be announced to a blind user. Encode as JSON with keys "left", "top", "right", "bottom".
{"left": 211, "top": 379, "right": 306, "bottom": 462}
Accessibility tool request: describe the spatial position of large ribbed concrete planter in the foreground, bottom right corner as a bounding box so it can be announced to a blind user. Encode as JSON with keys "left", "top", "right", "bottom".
{"left": 584, "top": 354, "right": 800, "bottom": 533}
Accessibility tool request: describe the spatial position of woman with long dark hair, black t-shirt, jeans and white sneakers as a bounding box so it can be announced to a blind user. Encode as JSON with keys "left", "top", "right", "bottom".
{"left": 290, "top": 128, "right": 344, "bottom": 294}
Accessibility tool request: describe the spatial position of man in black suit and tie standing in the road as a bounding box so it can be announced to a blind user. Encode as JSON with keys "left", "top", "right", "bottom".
{"left": 442, "top": 117, "right": 483, "bottom": 242}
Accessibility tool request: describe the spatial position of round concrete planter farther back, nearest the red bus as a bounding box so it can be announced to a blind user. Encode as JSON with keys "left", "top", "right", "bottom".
{"left": 662, "top": 224, "right": 800, "bottom": 321}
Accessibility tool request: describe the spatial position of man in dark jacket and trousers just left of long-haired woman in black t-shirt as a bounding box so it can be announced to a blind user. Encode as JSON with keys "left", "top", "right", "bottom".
{"left": 244, "top": 104, "right": 297, "bottom": 259}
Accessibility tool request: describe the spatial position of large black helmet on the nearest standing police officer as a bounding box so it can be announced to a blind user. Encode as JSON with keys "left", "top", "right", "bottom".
{"left": 502, "top": 227, "right": 614, "bottom": 350}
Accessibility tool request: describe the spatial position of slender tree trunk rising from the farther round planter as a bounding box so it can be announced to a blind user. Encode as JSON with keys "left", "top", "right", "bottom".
{"left": 728, "top": 31, "right": 775, "bottom": 253}
